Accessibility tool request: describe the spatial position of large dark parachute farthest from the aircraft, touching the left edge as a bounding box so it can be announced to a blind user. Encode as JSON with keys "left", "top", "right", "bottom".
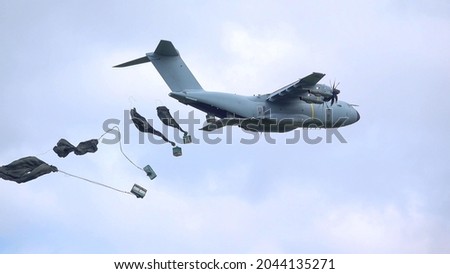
{"left": 0, "top": 156, "right": 58, "bottom": 184}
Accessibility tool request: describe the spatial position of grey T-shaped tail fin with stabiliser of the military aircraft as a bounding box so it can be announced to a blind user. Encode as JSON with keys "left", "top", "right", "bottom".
{"left": 114, "top": 40, "right": 203, "bottom": 92}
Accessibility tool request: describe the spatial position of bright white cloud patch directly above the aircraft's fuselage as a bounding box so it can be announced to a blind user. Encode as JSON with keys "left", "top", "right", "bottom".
{"left": 218, "top": 23, "right": 298, "bottom": 94}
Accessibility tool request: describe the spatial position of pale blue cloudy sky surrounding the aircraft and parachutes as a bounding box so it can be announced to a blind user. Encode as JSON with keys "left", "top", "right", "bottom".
{"left": 0, "top": 0, "right": 450, "bottom": 253}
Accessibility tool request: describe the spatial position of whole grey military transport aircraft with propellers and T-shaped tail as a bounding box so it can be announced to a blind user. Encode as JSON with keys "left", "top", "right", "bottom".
{"left": 115, "top": 40, "right": 360, "bottom": 132}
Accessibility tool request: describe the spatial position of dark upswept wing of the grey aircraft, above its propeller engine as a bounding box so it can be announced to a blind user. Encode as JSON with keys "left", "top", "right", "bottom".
{"left": 267, "top": 72, "right": 325, "bottom": 102}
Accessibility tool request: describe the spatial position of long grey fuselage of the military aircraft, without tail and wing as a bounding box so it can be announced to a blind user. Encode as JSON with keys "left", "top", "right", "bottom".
{"left": 169, "top": 90, "right": 360, "bottom": 132}
